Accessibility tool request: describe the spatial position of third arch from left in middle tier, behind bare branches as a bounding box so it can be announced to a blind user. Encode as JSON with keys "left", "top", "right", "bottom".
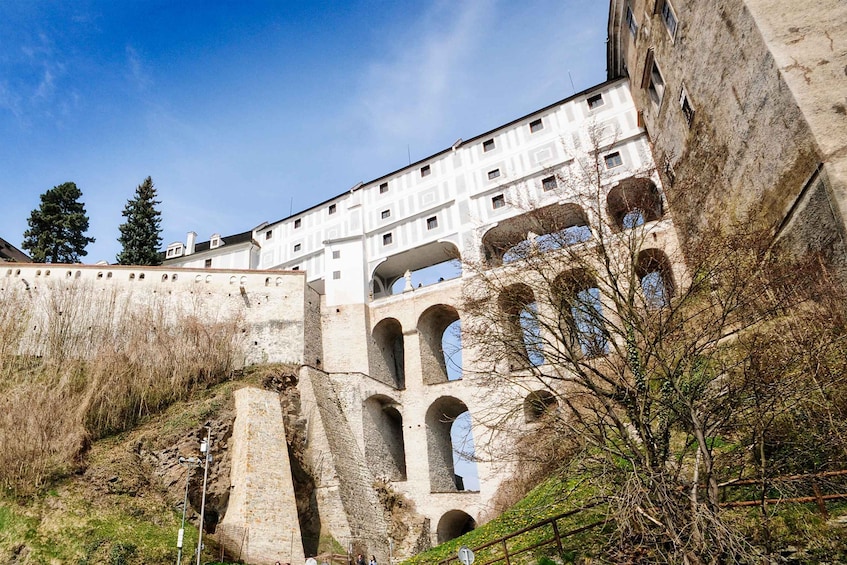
{"left": 497, "top": 283, "right": 544, "bottom": 370}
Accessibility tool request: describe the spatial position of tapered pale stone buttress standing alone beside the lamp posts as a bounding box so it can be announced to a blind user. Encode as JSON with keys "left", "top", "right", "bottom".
{"left": 219, "top": 388, "right": 305, "bottom": 565}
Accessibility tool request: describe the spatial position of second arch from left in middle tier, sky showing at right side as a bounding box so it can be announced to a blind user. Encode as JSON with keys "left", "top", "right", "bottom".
{"left": 418, "top": 304, "right": 461, "bottom": 385}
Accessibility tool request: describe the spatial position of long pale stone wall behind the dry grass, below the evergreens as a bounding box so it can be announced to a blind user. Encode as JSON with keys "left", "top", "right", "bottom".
{"left": 0, "top": 264, "right": 308, "bottom": 365}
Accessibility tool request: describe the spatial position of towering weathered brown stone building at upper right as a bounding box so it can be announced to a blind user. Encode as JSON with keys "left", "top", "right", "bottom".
{"left": 607, "top": 0, "right": 847, "bottom": 277}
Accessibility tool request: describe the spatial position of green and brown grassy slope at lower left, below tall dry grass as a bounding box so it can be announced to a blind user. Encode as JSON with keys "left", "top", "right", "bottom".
{"left": 0, "top": 374, "right": 250, "bottom": 565}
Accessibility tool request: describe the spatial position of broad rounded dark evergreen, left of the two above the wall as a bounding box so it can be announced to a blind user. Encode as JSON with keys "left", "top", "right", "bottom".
{"left": 22, "top": 182, "right": 94, "bottom": 263}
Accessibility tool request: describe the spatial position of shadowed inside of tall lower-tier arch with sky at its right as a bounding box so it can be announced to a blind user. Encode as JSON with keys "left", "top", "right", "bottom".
{"left": 425, "top": 396, "right": 476, "bottom": 492}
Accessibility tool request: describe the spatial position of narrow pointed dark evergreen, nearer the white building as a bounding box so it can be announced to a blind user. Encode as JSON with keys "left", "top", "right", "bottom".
{"left": 117, "top": 177, "right": 162, "bottom": 265}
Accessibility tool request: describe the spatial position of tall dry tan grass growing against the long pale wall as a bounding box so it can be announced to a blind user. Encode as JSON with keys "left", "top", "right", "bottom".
{"left": 0, "top": 285, "right": 239, "bottom": 496}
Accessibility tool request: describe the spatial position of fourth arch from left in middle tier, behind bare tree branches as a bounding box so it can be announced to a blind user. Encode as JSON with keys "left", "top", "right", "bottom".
{"left": 553, "top": 269, "right": 609, "bottom": 357}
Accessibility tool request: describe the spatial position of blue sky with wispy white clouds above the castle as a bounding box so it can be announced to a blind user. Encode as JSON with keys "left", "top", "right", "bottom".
{"left": 0, "top": 0, "right": 608, "bottom": 262}
